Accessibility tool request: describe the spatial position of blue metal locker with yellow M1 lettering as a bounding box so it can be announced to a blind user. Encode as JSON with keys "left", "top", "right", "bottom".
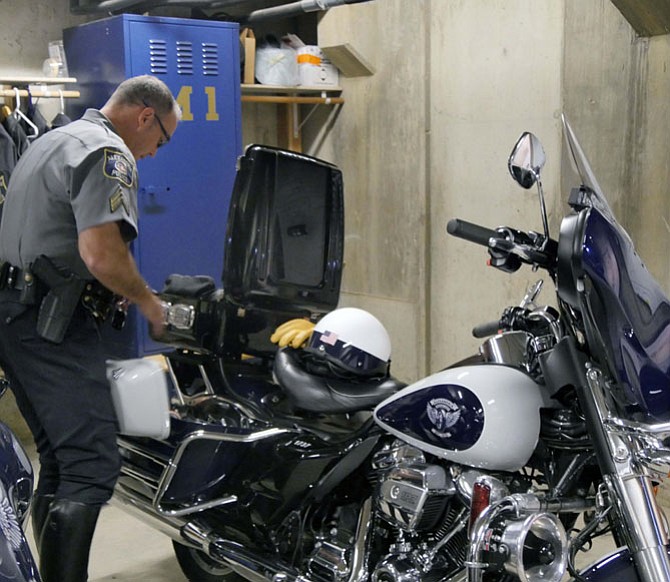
{"left": 63, "top": 14, "right": 242, "bottom": 357}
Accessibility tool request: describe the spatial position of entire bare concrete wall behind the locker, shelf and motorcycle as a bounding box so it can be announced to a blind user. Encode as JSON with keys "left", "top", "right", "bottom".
{"left": 0, "top": 0, "right": 670, "bottom": 392}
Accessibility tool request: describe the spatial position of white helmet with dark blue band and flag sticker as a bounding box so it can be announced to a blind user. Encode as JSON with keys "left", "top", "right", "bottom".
{"left": 305, "top": 307, "right": 391, "bottom": 376}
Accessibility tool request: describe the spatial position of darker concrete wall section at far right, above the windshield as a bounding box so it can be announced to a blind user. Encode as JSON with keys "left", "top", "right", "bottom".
{"left": 563, "top": 0, "right": 670, "bottom": 290}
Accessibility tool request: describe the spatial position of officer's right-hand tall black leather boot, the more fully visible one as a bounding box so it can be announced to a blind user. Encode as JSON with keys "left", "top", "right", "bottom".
{"left": 39, "top": 499, "right": 100, "bottom": 582}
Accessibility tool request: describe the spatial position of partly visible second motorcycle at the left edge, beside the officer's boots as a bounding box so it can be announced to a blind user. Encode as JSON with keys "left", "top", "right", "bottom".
{"left": 0, "top": 378, "right": 40, "bottom": 582}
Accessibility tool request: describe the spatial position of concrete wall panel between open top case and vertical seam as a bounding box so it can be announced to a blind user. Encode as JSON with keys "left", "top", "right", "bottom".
{"left": 316, "top": 0, "right": 431, "bottom": 378}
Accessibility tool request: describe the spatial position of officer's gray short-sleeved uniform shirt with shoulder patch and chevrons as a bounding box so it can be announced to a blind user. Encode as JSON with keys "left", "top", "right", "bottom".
{"left": 0, "top": 109, "right": 137, "bottom": 279}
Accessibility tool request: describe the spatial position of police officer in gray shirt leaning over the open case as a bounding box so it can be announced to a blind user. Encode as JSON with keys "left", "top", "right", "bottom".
{"left": 0, "top": 75, "right": 181, "bottom": 582}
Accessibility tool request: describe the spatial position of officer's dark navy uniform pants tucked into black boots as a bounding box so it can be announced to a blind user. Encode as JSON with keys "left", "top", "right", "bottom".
{"left": 0, "top": 290, "right": 120, "bottom": 504}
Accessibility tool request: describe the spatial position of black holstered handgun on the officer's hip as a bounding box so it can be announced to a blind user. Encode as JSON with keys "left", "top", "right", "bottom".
{"left": 31, "top": 255, "right": 86, "bottom": 344}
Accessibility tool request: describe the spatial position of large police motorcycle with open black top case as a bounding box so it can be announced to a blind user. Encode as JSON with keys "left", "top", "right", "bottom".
{"left": 110, "top": 119, "right": 670, "bottom": 582}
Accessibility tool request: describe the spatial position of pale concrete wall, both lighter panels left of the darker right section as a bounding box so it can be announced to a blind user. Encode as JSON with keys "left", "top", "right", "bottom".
{"left": 314, "top": 0, "right": 564, "bottom": 380}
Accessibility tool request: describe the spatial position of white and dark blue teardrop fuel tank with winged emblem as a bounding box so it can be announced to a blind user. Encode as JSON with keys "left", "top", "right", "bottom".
{"left": 374, "top": 364, "right": 546, "bottom": 471}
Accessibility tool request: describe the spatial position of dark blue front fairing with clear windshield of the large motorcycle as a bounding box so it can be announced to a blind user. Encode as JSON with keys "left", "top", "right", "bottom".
{"left": 559, "top": 116, "right": 670, "bottom": 422}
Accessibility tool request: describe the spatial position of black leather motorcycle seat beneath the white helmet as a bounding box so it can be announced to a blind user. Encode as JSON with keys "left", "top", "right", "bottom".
{"left": 273, "top": 348, "right": 406, "bottom": 414}
